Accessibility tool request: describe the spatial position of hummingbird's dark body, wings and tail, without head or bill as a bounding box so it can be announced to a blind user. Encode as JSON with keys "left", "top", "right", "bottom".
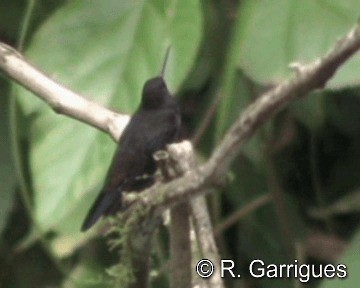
{"left": 81, "top": 104, "right": 180, "bottom": 231}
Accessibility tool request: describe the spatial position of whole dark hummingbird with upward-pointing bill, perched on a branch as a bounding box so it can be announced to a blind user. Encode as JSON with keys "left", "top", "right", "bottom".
{"left": 81, "top": 49, "right": 181, "bottom": 231}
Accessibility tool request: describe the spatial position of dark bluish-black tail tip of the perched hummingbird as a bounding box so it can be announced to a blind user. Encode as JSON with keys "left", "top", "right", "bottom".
{"left": 81, "top": 191, "right": 121, "bottom": 232}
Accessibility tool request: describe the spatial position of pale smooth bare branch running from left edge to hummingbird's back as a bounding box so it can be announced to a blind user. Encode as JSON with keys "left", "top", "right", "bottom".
{"left": 0, "top": 42, "right": 129, "bottom": 140}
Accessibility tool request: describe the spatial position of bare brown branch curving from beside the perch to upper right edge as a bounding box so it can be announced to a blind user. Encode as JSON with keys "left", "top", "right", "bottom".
{"left": 206, "top": 25, "right": 360, "bottom": 177}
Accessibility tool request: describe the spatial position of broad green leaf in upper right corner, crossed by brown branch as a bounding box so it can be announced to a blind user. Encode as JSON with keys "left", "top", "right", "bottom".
{"left": 238, "top": 0, "right": 360, "bottom": 87}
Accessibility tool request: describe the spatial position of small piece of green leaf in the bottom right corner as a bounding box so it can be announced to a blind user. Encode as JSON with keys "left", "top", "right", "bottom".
{"left": 321, "top": 230, "right": 360, "bottom": 288}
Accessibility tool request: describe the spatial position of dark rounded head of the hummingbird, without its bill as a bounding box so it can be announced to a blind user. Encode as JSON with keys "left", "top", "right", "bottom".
{"left": 141, "top": 77, "right": 170, "bottom": 109}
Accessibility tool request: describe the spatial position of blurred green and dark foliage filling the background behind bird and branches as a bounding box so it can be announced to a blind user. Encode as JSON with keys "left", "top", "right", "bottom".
{"left": 0, "top": 0, "right": 360, "bottom": 288}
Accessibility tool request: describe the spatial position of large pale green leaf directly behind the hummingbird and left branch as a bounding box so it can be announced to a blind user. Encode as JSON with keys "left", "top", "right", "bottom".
{"left": 20, "top": 0, "right": 202, "bottom": 236}
